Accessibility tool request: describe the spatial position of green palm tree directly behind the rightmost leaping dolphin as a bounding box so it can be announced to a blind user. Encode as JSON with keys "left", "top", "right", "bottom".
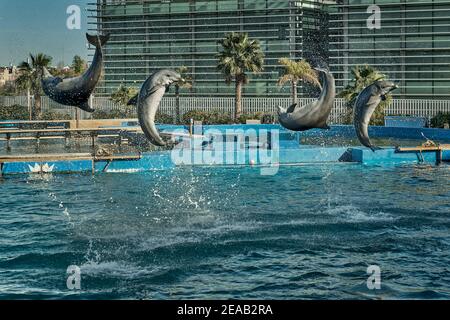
{"left": 337, "top": 65, "right": 392, "bottom": 125}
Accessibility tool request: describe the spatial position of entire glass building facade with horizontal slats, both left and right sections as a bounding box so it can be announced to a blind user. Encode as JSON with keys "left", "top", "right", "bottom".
{"left": 89, "top": 0, "right": 450, "bottom": 99}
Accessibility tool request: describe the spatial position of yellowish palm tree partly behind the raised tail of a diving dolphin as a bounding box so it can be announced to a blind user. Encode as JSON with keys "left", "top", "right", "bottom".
{"left": 278, "top": 58, "right": 321, "bottom": 104}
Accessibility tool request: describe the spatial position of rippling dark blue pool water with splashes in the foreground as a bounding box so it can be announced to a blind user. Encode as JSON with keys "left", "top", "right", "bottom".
{"left": 0, "top": 165, "right": 450, "bottom": 299}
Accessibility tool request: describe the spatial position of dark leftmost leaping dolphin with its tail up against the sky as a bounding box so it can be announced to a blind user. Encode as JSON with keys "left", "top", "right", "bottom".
{"left": 42, "top": 34, "right": 110, "bottom": 112}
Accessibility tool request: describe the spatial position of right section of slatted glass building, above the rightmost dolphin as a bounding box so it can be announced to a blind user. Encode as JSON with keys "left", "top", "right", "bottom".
{"left": 328, "top": 0, "right": 450, "bottom": 99}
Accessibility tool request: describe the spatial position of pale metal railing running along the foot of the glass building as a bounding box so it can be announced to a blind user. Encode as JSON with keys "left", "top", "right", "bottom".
{"left": 0, "top": 96, "right": 450, "bottom": 124}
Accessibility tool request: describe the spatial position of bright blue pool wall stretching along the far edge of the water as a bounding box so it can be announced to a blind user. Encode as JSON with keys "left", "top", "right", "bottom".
{"left": 2, "top": 125, "right": 450, "bottom": 174}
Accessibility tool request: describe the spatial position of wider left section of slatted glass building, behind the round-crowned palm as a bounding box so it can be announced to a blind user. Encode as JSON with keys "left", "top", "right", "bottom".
{"left": 89, "top": 0, "right": 333, "bottom": 96}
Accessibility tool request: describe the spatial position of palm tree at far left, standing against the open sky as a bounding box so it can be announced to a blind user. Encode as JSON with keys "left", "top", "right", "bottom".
{"left": 15, "top": 53, "right": 52, "bottom": 119}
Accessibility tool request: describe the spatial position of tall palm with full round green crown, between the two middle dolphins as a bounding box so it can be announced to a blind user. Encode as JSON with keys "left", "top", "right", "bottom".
{"left": 217, "top": 32, "right": 264, "bottom": 121}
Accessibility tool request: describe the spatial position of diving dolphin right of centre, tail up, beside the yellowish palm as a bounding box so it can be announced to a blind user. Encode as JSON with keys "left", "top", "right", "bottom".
{"left": 278, "top": 68, "right": 336, "bottom": 131}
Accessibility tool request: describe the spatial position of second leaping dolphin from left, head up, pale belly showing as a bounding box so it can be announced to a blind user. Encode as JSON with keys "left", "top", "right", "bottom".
{"left": 137, "top": 69, "right": 182, "bottom": 147}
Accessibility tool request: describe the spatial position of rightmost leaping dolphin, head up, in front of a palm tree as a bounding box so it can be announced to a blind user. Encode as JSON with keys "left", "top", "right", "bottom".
{"left": 353, "top": 81, "right": 398, "bottom": 152}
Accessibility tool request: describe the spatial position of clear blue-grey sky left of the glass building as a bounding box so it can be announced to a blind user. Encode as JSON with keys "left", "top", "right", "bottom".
{"left": 0, "top": 0, "right": 90, "bottom": 66}
